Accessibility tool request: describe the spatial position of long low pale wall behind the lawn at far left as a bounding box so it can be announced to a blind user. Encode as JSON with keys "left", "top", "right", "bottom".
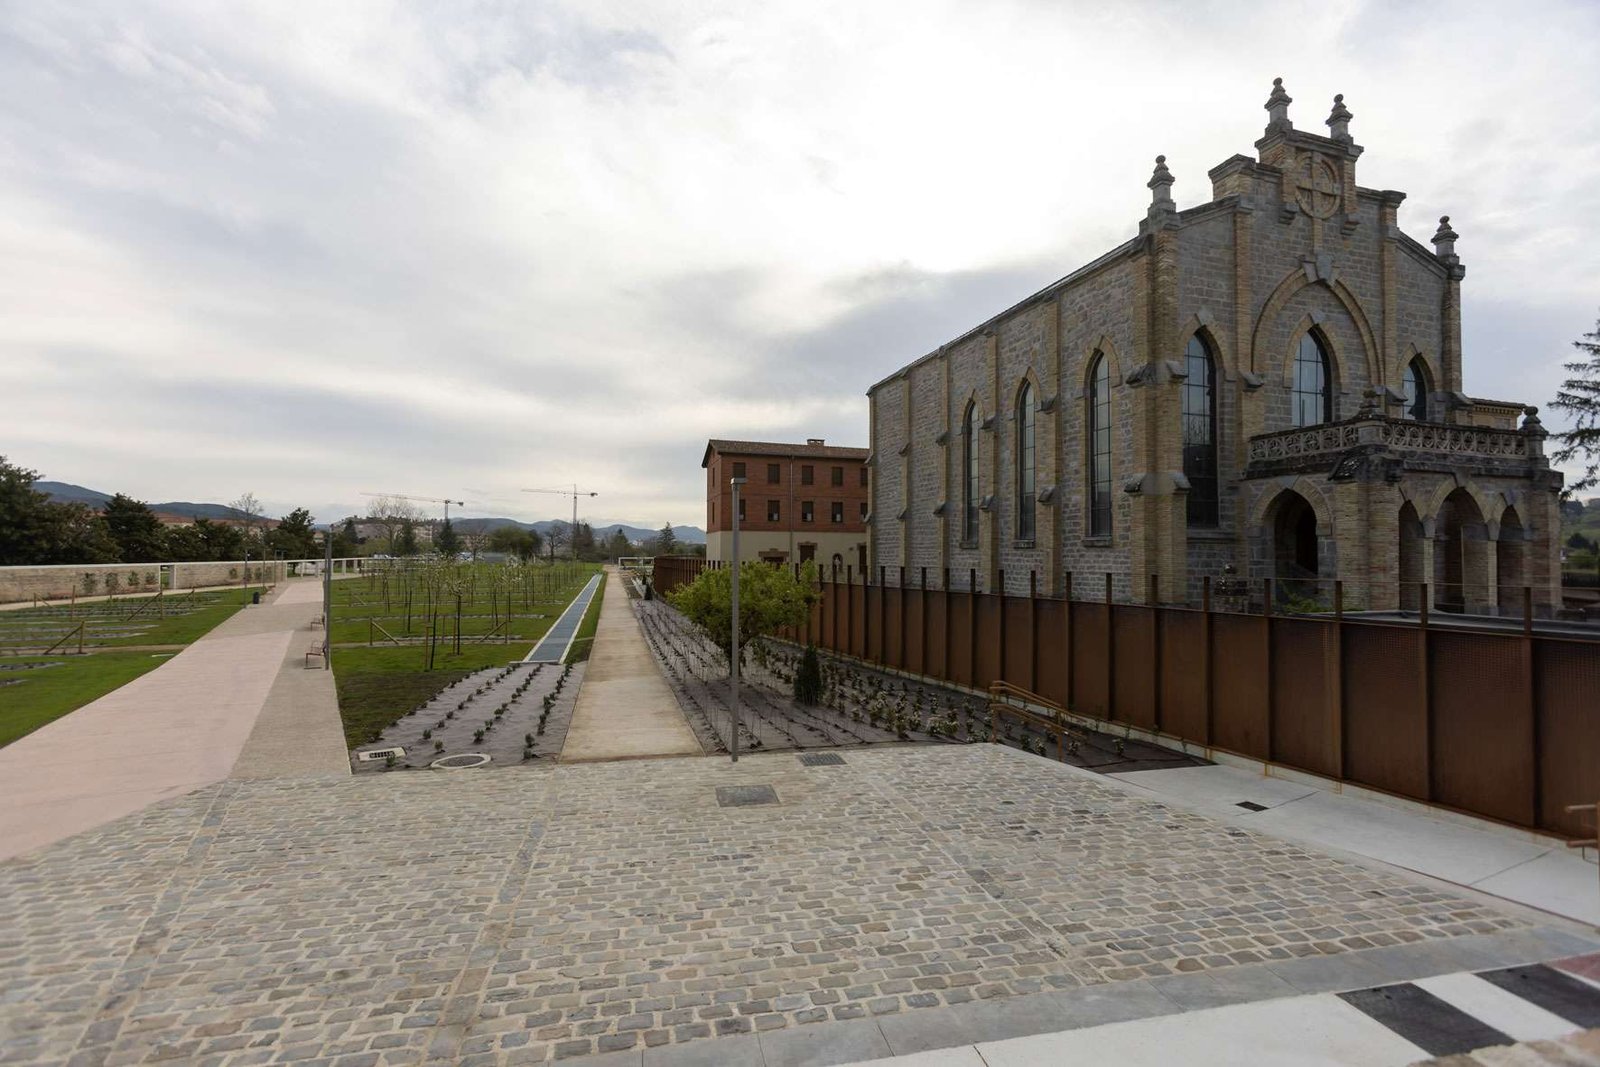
{"left": 0, "top": 560, "right": 365, "bottom": 603}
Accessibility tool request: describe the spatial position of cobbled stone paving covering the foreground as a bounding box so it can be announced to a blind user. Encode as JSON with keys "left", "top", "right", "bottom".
{"left": 0, "top": 748, "right": 1589, "bottom": 1064}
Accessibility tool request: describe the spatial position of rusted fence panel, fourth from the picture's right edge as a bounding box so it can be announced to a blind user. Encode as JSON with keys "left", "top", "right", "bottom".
{"left": 1272, "top": 619, "right": 1339, "bottom": 777}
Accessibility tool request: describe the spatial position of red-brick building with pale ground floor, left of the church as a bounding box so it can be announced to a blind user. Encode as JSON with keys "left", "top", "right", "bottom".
{"left": 701, "top": 437, "right": 869, "bottom": 571}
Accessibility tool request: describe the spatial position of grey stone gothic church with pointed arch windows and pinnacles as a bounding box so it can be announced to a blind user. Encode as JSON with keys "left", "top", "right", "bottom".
{"left": 869, "top": 78, "right": 1562, "bottom": 614}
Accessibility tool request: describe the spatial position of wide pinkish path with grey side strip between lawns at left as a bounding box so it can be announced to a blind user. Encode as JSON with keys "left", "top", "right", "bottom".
{"left": 0, "top": 579, "right": 349, "bottom": 859}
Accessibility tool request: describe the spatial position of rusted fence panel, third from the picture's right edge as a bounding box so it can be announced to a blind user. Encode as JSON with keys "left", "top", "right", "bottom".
{"left": 1342, "top": 625, "right": 1429, "bottom": 800}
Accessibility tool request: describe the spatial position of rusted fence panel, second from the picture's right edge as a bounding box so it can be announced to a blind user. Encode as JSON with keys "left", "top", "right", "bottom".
{"left": 1429, "top": 627, "right": 1534, "bottom": 825}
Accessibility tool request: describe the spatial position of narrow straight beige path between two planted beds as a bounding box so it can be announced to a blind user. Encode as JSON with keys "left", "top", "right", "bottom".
{"left": 562, "top": 566, "right": 701, "bottom": 763}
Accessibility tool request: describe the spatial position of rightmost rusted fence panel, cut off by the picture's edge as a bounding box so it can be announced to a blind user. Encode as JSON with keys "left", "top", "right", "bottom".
{"left": 1533, "top": 638, "right": 1600, "bottom": 837}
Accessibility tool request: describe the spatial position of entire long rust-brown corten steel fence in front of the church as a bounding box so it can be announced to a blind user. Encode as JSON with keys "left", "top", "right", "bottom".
{"left": 654, "top": 557, "right": 1600, "bottom": 835}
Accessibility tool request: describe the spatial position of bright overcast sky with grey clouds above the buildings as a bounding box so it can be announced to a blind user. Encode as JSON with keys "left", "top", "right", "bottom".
{"left": 0, "top": 0, "right": 1600, "bottom": 526}
